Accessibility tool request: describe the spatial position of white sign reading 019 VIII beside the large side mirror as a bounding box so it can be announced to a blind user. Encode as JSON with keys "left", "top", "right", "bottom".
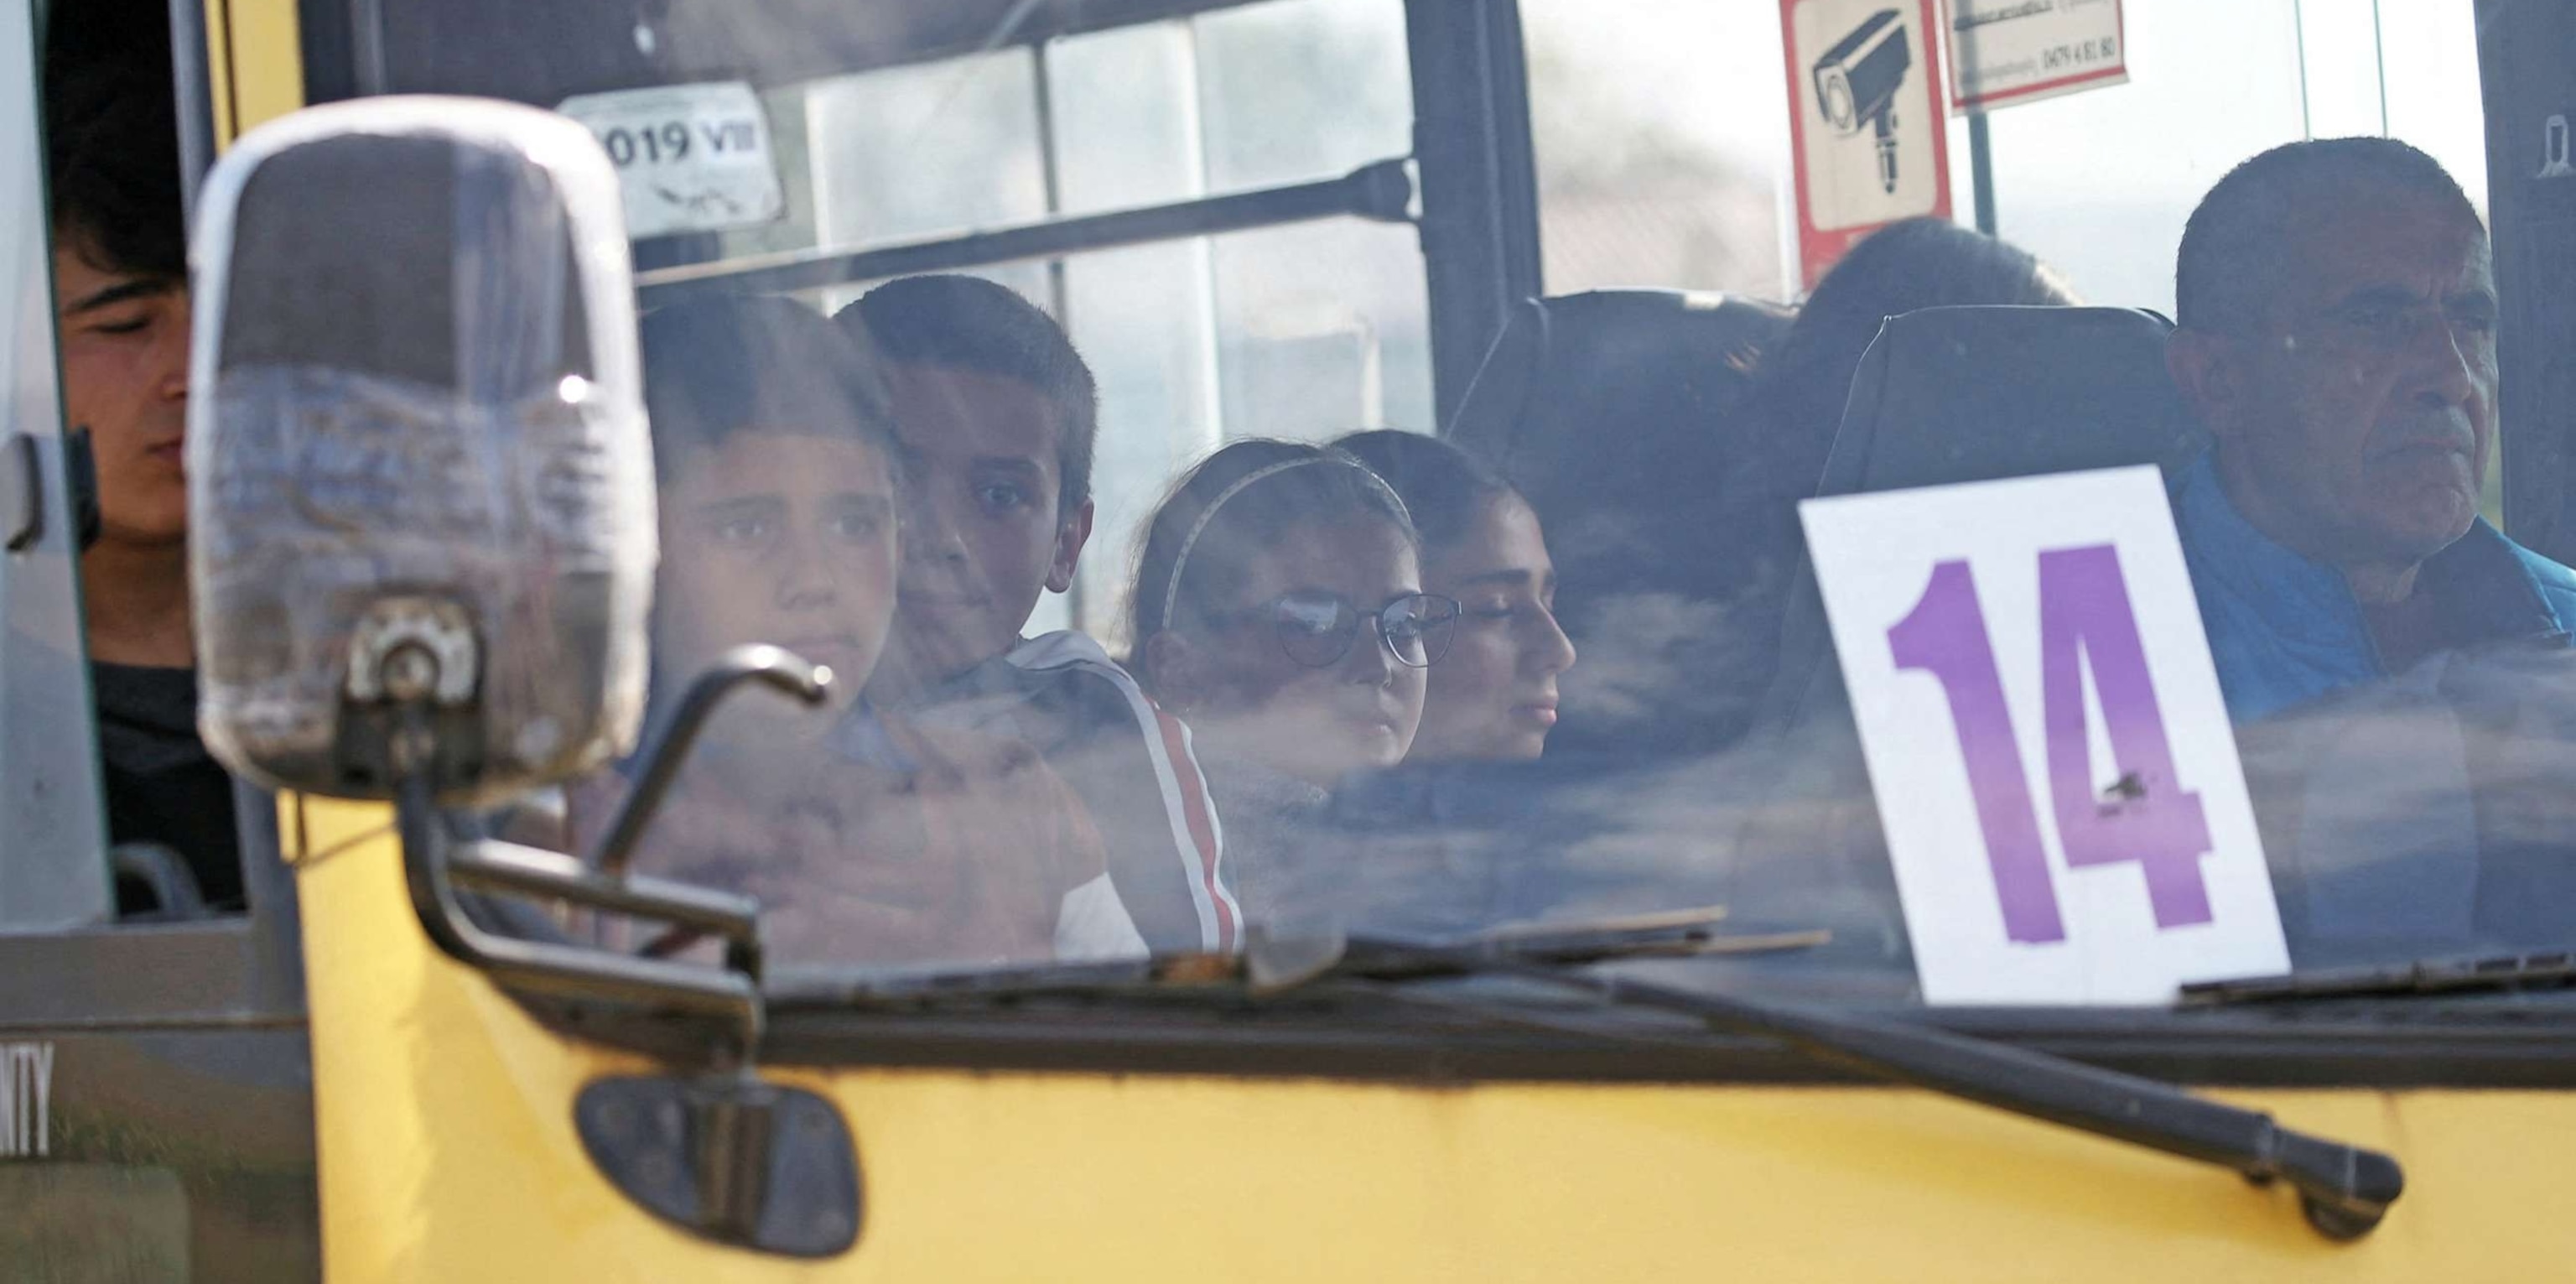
{"left": 557, "top": 80, "right": 788, "bottom": 240}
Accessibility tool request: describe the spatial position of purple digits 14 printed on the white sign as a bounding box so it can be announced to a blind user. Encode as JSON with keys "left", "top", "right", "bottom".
{"left": 1888, "top": 544, "right": 2210, "bottom": 941}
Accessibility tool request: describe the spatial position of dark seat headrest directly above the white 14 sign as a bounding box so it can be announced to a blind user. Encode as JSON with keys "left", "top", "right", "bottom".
{"left": 1819, "top": 307, "right": 2208, "bottom": 495}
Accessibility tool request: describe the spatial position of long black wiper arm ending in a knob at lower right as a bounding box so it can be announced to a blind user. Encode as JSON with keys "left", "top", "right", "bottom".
{"left": 1247, "top": 931, "right": 2406, "bottom": 1240}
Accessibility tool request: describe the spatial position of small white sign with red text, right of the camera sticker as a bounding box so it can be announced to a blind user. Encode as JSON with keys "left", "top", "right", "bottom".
{"left": 1947, "top": 0, "right": 2127, "bottom": 111}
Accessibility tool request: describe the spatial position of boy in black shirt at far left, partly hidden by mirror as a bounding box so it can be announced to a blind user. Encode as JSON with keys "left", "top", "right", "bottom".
{"left": 44, "top": 5, "right": 242, "bottom": 910}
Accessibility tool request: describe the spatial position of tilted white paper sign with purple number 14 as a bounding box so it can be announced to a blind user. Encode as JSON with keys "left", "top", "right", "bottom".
{"left": 1800, "top": 466, "right": 2290, "bottom": 1003}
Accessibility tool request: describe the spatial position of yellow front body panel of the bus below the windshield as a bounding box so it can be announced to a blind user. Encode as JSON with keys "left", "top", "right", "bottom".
{"left": 286, "top": 799, "right": 2576, "bottom": 1284}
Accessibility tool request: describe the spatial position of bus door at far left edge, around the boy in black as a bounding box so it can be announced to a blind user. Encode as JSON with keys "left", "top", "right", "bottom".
{"left": 0, "top": 5, "right": 322, "bottom": 1281}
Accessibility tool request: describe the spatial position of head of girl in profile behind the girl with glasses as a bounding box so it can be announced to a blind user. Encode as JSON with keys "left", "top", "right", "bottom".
{"left": 1334, "top": 430, "right": 1574, "bottom": 763}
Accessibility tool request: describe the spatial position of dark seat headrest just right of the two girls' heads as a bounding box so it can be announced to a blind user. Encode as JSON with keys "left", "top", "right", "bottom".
{"left": 1447, "top": 289, "right": 1790, "bottom": 482}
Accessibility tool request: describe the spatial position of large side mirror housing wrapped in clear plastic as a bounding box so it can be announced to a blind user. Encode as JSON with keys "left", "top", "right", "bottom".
{"left": 185, "top": 98, "right": 654, "bottom": 802}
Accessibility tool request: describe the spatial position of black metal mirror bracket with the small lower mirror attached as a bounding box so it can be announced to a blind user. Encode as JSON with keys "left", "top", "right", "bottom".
{"left": 378, "top": 637, "right": 858, "bottom": 1258}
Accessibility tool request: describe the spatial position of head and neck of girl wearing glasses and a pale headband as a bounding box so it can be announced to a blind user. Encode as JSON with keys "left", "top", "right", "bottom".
{"left": 1131, "top": 441, "right": 1458, "bottom": 918}
